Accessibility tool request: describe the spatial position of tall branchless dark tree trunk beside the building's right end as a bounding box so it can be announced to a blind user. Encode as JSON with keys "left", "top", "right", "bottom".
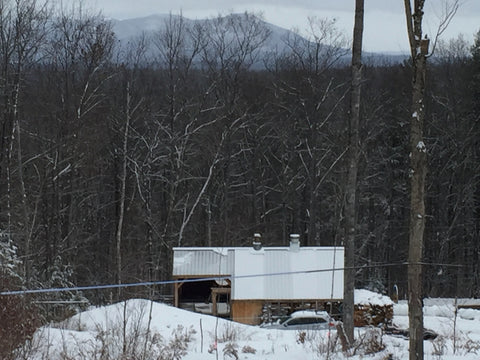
{"left": 343, "top": 0, "right": 364, "bottom": 344}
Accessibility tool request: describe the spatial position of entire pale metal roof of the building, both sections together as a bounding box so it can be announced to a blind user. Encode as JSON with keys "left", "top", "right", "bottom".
{"left": 173, "top": 247, "right": 344, "bottom": 300}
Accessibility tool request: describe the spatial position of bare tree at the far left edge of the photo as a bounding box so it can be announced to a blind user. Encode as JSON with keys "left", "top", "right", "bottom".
{"left": 0, "top": 0, "right": 49, "bottom": 281}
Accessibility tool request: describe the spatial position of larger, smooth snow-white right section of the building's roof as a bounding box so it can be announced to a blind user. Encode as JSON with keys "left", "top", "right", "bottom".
{"left": 232, "top": 247, "right": 344, "bottom": 300}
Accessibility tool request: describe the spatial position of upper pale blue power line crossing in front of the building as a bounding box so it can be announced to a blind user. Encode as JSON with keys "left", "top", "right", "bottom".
{"left": 0, "top": 262, "right": 465, "bottom": 296}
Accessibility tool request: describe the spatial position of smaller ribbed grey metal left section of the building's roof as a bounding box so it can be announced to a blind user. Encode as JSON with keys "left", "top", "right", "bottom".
{"left": 173, "top": 248, "right": 233, "bottom": 276}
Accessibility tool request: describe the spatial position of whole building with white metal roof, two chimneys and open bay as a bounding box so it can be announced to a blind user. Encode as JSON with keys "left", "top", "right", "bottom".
{"left": 173, "top": 235, "right": 344, "bottom": 324}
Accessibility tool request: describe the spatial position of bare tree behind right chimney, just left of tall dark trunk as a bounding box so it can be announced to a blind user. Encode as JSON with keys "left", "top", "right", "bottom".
{"left": 273, "top": 18, "right": 348, "bottom": 245}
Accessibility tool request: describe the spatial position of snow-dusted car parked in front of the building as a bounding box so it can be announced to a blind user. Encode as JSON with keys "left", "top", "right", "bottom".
{"left": 262, "top": 310, "right": 335, "bottom": 330}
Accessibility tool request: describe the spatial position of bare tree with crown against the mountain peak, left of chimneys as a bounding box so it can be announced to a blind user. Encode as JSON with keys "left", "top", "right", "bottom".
{"left": 202, "top": 13, "right": 270, "bottom": 244}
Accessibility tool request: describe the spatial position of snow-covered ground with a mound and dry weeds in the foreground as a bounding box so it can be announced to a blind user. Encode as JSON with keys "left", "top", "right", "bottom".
{"left": 16, "top": 294, "right": 480, "bottom": 360}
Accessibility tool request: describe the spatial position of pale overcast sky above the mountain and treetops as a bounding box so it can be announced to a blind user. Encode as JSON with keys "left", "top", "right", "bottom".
{"left": 70, "top": 0, "right": 480, "bottom": 52}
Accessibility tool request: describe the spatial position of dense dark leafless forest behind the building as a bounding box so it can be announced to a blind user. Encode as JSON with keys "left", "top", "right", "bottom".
{"left": 0, "top": 0, "right": 480, "bottom": 303}
